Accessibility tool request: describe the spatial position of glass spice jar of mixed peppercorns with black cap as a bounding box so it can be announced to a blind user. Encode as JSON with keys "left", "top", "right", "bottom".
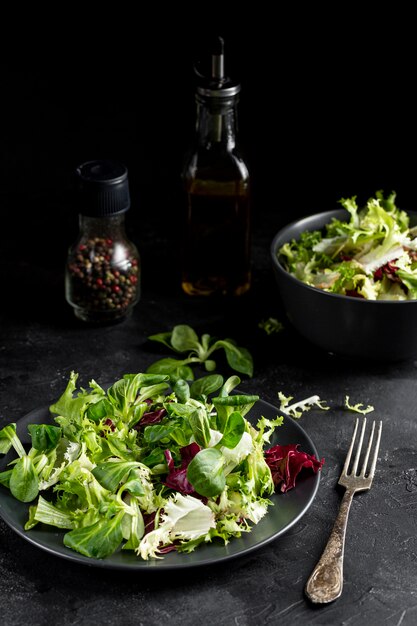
{"left": 65, "top": 161, "right": 141, "bottom": 324}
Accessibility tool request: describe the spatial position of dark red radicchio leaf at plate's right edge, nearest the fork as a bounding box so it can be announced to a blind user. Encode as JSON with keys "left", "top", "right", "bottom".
{"left": 265, "top": 443, "right": 324, "bottom": 493}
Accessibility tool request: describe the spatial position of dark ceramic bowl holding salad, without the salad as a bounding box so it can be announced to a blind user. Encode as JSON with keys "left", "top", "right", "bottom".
{"left": 270, "top": 209, "right": 417, "bottom": 361}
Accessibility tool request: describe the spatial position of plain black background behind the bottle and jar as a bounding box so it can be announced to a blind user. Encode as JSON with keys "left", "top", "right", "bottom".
{"left": 0, "top": 3, "right": 417, "bottom": 294}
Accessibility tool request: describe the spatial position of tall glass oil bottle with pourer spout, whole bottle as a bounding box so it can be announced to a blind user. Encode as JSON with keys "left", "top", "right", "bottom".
{"left": 182, "top": 38, "right": 251, "bottom": 296}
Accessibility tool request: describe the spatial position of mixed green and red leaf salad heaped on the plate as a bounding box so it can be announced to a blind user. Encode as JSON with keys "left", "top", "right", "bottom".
{"left": 0, "top": 372, "right": 324, "bottom": 560}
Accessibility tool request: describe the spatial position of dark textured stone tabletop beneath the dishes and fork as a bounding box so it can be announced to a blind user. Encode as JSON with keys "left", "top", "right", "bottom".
{"left": 0, "top": 210, "right": 417, "bottom": 626}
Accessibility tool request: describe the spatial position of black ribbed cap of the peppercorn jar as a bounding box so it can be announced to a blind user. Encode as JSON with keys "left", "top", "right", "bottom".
{"left": 76, "top": 160, "right": 130, "bottom": 217}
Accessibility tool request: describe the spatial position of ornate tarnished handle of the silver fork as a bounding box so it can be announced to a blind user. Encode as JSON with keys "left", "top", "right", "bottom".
{"left": 305, "top": 489, "right": 354, "bottom": 603}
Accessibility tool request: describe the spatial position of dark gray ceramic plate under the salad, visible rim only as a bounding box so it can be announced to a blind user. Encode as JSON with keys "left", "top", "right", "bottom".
{"left": 0, "top": 400, "right": 320, "bottom": 570}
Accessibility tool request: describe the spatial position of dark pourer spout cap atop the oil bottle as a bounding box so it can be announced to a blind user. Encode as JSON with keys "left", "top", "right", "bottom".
{"left": 194, "top": 37, "right": 240, "bottom": 98}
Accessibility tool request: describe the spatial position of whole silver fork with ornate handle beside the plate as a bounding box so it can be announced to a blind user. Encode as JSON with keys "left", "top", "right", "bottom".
{"left": 305, "top": 417, "right": 382, "bottom": 604}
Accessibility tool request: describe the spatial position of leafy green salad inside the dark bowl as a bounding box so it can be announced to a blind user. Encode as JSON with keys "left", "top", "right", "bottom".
{"left": 278, "top": 191, "right": 417, "bottom": 300}
